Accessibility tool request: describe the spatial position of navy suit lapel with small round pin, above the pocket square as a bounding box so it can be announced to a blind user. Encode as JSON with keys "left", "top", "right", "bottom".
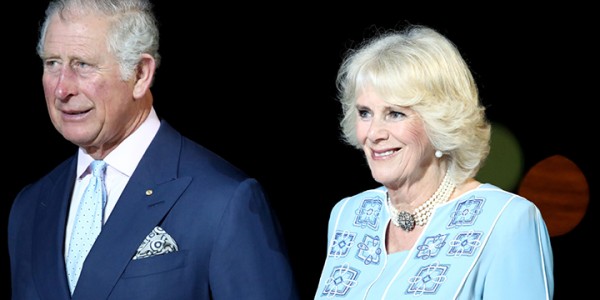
{"left": 73, "top": 123, "right": 192, "bottom": 299}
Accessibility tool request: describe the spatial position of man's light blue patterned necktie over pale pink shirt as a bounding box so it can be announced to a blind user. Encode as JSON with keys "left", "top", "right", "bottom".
{"left": 67, "top": 160, "right": 106, "bottom": 294}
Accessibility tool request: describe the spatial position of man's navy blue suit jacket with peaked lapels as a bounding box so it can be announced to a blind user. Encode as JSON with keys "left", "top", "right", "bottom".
{"left": 8, "top": 121, "right": 298, "bottom": 300}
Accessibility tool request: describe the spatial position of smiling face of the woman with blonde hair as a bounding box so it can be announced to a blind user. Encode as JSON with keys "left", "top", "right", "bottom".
{"left": 356, "top": 88, "right": 435, "bottom": 187}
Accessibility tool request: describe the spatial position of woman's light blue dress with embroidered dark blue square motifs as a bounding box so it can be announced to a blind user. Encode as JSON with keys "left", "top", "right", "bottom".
{"left": 315, "top": 184, "right": 554, "bottom": 300}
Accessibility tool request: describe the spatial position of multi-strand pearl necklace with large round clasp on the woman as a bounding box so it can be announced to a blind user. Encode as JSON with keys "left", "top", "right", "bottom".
{"left": 386, "top": 171, "right": 455, "bottom": 231}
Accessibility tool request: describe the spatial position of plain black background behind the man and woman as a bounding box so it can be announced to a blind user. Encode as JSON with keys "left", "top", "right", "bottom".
{"left": 0, "top": 1, "right": 598, "bottom": 299}
